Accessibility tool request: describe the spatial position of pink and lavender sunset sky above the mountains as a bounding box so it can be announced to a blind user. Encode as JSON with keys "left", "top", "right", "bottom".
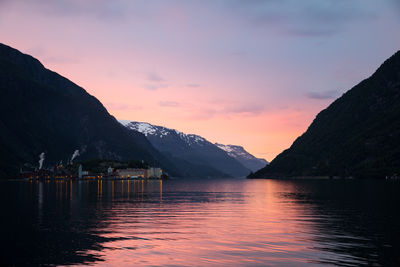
{"left": 0, "top": 0, "right": 400, "bottom": 161}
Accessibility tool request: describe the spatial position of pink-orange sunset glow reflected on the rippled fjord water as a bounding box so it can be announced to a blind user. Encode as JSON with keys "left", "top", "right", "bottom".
{"left": 88, "top": 180, "right": 315, "bottom": 266}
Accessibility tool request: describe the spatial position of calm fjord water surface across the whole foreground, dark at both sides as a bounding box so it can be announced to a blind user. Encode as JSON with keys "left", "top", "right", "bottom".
{"left": 0, "top": 180, "right": 400, "bottom": 266}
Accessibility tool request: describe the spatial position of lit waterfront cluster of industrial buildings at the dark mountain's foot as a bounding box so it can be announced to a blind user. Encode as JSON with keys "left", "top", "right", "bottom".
{"left": 20, "top": 160, "right": 168, "bottom": 180}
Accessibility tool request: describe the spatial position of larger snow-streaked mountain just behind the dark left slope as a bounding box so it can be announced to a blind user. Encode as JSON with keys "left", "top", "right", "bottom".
{"left": 120, "top": 121, "right": 250, "bottom": 177}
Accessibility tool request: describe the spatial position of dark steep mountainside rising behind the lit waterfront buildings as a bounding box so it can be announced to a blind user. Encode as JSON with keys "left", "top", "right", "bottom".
{"left": 0, "top": 44, "right": 178, "bottom": 178}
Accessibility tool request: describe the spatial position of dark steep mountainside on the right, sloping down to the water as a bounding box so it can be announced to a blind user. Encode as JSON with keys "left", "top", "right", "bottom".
{"left": 251, "top": 51, "right": 400, "bottom": 178}
